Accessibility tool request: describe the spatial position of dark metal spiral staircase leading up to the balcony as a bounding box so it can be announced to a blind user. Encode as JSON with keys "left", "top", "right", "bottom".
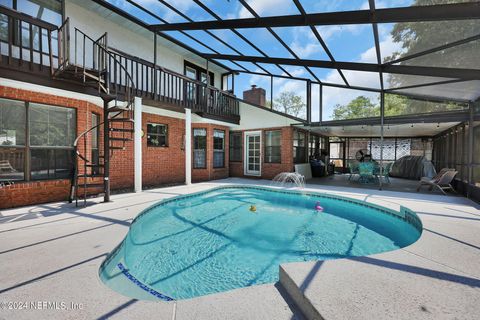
{"left": 53, "top": 19, "right": 135, "bottom": 206}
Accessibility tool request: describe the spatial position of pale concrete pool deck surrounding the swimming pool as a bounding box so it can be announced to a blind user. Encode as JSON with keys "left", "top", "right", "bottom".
{"left": 0, "top": 178, "right": 480, "bottom": 320}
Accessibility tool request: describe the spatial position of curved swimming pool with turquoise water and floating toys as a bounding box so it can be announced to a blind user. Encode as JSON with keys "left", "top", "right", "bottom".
{"left": 100, "top": 186, "right": 422, "bottom": 301}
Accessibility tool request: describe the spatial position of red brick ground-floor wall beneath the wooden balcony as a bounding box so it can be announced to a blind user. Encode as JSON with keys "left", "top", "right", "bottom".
{"left": 0, "top": 86, "right": 229, "bottom": 209}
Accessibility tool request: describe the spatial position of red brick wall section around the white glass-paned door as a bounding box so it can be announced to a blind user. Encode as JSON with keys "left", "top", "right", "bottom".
{"left": 230, "top": 127, "right": 294, "bottom": 179}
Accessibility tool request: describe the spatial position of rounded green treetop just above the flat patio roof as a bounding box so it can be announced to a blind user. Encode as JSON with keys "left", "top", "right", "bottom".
{"left": 333, "top": 96, "right": 380, "bottom": 120}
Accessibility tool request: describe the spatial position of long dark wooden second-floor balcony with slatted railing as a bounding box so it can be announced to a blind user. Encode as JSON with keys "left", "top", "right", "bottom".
{"left": 0, "top": 6, "right": 240, "bottom": 123}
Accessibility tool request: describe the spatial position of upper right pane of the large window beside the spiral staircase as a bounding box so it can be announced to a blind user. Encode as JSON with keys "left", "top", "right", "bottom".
{"left": 29, "top": 103, "right": 75, "bottom": 147}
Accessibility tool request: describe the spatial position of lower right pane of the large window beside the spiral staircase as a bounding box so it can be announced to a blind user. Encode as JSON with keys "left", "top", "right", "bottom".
{"left": 30, "top": 149, "right": 73, "bottom": 180}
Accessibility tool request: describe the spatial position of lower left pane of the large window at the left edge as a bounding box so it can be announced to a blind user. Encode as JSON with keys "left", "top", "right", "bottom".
{"left": 0, "top": 148, "right": 25, "bottom": 182}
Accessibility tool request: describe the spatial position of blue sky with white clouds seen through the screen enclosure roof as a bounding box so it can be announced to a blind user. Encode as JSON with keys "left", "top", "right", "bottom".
{"left": 110, "top": 0, "right": 413, "bottom": 121}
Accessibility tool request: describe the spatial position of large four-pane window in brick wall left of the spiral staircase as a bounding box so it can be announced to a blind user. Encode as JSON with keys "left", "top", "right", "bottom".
{"left": 0, "top": 99, "right": 76, "bottom": 181}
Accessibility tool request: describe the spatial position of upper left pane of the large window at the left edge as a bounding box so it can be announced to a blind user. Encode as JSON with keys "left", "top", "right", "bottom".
{"left": 0, "top": 99, "right": 26, "bottom": 146}
